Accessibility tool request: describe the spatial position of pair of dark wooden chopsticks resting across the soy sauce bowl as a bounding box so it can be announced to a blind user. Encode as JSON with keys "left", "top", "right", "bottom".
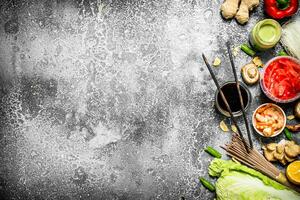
{"left": 202, "top": 41, "right": 253, "bottom": 153}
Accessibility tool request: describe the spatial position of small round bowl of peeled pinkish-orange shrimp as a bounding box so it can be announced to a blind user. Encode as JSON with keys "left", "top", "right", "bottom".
{"left": 252, "top": 103, "right": 286, "bottom": 137}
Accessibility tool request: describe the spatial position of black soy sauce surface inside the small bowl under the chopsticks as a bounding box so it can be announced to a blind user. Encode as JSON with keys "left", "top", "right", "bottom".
{"left": 217, "top": 83, "right": 249, "bottom": 112}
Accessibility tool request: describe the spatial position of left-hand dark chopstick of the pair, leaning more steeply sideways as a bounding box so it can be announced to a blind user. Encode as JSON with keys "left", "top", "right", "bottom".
{"left": 202, "top": 53, "right": 249, "bottom": 153}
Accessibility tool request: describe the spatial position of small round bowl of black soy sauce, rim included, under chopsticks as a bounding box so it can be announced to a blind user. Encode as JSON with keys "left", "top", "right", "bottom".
{"left": 215, "top": 81, "right": 251, "bottom": 117}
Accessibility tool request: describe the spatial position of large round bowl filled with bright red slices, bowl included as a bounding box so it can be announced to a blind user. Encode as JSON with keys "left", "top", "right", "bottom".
{"left": 260, "top": 56, "right": 300, "bottom": 103}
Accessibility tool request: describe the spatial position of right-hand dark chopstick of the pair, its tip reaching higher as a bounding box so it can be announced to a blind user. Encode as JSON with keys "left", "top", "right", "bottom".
{"left": 226, "top": 41, "right": 253, "bottom": 149}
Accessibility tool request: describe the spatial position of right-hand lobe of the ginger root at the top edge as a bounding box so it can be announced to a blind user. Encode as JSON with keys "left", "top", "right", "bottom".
{"left": 235, "top": 0, "right": 259, "bottom": 24}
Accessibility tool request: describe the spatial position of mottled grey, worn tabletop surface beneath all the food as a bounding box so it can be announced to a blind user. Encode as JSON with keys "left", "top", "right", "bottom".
{"left": 0, "top": 0, "right": 298, "bottom": 200}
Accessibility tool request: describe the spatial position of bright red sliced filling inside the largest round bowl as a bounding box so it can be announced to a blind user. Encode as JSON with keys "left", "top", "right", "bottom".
{"left": 263, "top": 58, "right": 300, "bottom": 100}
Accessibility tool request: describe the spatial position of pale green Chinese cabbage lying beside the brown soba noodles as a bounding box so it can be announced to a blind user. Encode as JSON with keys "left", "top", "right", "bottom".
{"left": 209, "top": 158, "right": 300, "bottom": 200}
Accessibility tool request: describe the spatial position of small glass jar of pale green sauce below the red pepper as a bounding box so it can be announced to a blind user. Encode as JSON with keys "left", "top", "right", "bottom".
{"left": 250, "top": 19, "right": 281, "bottom": 51}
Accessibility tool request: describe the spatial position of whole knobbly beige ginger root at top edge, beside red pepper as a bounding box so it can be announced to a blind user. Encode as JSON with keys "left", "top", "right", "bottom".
{"left": 221, "top": 0, "right": 259, "bottom": 24}
